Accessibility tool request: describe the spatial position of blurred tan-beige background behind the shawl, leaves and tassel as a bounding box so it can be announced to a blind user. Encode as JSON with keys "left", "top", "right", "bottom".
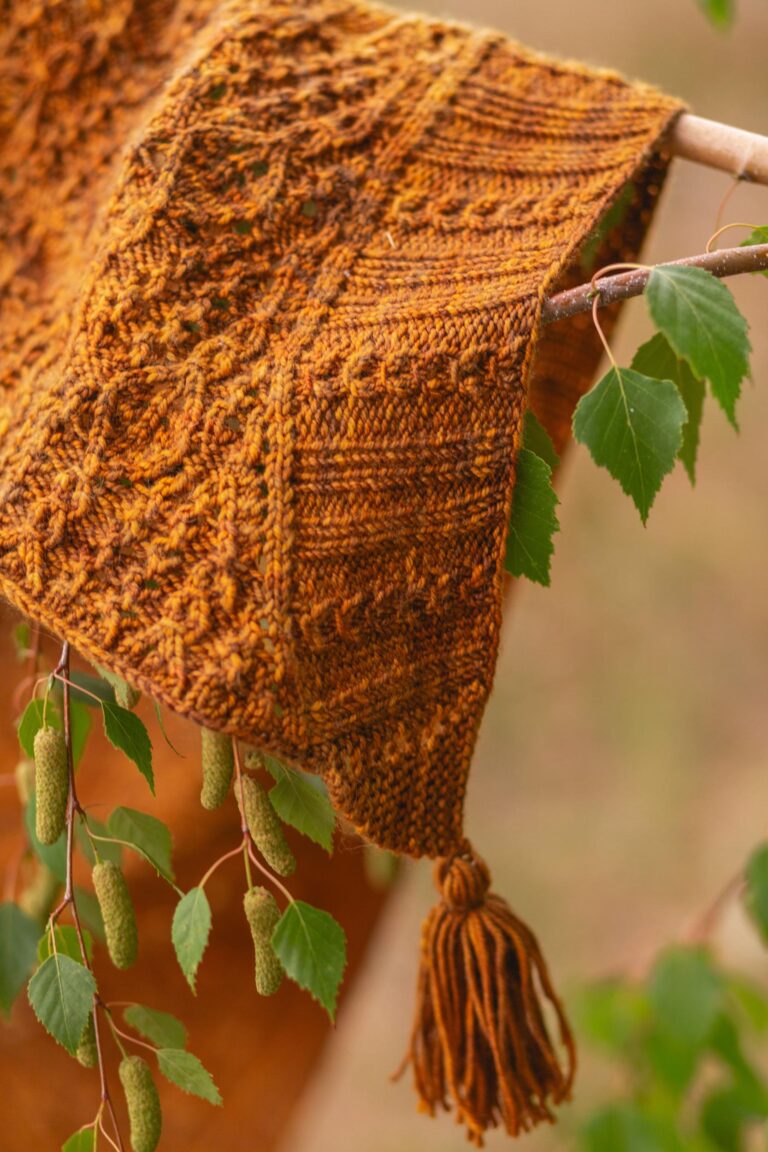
{"left": 281, "top": 0, "right": 768, "bottom": 1152}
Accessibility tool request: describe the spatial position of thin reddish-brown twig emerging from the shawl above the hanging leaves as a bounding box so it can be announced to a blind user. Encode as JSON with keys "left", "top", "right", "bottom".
{"left": 541, "top": 244, "right": 768, "bottom": 324}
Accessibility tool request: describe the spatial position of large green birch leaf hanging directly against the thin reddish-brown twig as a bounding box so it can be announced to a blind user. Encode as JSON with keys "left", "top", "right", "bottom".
{"left": 645, "top": 264, "right": 750, "bottom": 427}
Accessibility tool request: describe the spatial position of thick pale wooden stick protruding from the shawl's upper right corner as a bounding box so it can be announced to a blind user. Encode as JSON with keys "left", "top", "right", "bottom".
{"left": 667, "top": 113, "right": 768, "bottom": 184}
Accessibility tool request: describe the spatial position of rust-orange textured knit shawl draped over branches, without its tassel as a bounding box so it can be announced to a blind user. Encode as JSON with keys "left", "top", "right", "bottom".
{"left": 0, "top": 0, "right": 678, "bottom": 855}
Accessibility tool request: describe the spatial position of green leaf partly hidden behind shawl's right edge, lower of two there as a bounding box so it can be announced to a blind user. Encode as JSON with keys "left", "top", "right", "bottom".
{"left": 504, "top": 448, "right": 560, "bottom": 585}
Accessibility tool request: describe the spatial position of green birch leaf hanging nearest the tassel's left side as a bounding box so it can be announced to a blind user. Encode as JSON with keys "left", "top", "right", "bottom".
{"left": 272, "top": 900, "right": 347, "bottom": 1020}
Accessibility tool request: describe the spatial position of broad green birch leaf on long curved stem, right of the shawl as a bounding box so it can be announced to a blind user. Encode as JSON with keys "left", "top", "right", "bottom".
{"left": 573, "top": 367, "right": 687, "bottom": 524}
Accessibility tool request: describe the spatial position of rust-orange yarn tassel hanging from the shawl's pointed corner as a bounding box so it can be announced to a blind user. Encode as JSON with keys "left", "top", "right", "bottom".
{"left": 396, "top": 844, "right": 576, "bottom": 1147}
